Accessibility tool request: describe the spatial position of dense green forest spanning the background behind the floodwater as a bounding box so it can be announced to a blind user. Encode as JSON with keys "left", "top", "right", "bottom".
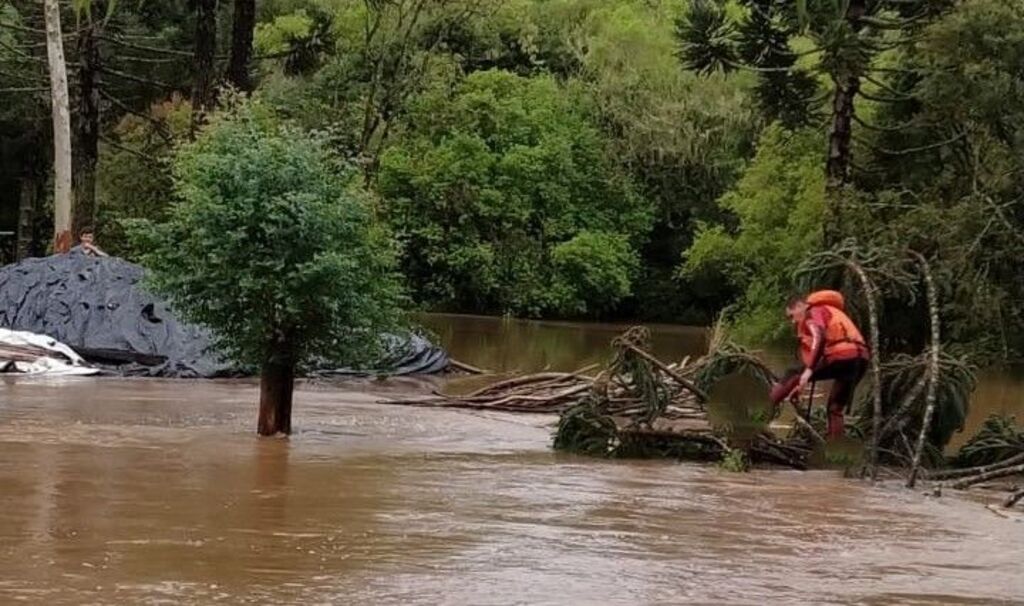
{"left": 0, "top": 0, "right": 1024, "bottom": 359}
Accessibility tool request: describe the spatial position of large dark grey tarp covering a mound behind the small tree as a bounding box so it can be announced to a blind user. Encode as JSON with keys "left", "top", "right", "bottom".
{"left": 0, "top": 252, "right": 449, "bottom": 378}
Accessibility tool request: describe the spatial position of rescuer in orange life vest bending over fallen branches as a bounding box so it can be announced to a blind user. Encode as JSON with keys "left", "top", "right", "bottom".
{"left": 771, "top": 291, "right": 871, "bottom": 439}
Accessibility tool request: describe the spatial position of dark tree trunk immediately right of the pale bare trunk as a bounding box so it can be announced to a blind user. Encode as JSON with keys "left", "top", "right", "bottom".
{"left": 72, "top": 8, "right": 102, "bottom": 239}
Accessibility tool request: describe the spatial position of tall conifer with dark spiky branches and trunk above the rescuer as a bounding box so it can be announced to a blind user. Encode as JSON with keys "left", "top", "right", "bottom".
{"left": 678, "top": 0, "right": 949, "bottom": 245}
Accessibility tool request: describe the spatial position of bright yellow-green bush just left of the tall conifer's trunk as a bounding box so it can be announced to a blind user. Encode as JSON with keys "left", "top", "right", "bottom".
{"left": 681, "top": 125, "right": 824, "bottom": 339}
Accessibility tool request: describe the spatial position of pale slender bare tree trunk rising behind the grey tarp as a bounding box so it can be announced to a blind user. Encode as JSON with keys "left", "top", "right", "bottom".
{"left": 43, "top": 0, "right": 73, "bottom": 253}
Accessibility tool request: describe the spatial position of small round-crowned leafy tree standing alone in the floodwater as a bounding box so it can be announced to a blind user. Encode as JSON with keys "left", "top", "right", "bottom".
{"left": 133, "top": 102, "right": 400, "bottom": 435}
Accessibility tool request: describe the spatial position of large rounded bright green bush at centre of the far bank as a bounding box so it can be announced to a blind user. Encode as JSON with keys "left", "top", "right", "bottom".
{"left": 378, "top": 71, "right": 650, "bottom": 315}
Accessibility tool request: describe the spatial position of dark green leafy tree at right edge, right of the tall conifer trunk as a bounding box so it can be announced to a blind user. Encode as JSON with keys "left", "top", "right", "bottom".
{"left": 857, "top": 0, "right": 1024, "bottom": 358}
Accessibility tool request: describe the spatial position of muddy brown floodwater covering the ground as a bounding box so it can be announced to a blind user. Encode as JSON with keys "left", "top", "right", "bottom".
{"left": 0, "top": 316, "right": 1024, "bottom": 605}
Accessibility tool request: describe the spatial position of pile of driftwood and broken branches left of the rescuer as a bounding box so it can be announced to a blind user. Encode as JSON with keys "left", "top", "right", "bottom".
{"left": 387, "top": 327, "right": 820, "bottom": 469}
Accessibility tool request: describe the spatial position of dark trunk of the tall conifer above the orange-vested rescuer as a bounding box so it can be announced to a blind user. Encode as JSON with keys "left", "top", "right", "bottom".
{"left": 823, "top": 0, "right": 867, "bottom": 248}
